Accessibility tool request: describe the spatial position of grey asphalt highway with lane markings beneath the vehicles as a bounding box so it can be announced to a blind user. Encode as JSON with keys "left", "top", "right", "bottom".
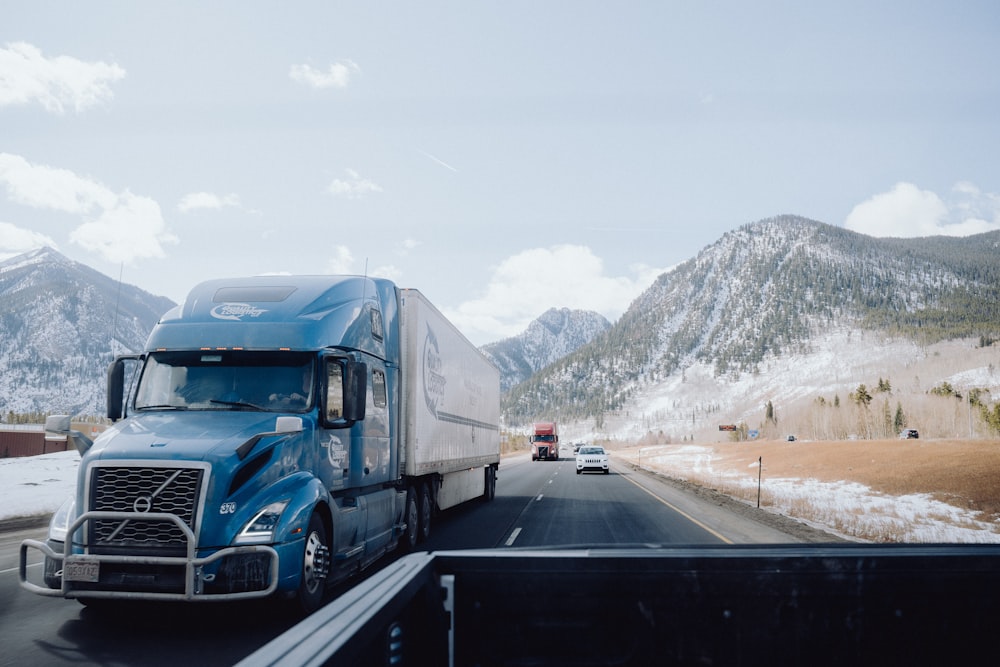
{"left": 0, "top": 451, "right": 797, "bottom": 667}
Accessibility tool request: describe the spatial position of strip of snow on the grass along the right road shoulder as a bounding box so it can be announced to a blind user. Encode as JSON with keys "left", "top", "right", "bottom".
{"left": 615, "top": 445, "right": 1000, "bottom": 544}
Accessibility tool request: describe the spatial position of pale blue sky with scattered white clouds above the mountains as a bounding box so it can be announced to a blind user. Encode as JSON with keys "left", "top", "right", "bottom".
{"left": 0, "top": 0, "right": 1000, "bottom": 344}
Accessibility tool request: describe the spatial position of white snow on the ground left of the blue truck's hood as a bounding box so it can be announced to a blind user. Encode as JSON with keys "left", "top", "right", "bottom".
{"left": 0, "top": 449, "right": 80, "bottom": 521}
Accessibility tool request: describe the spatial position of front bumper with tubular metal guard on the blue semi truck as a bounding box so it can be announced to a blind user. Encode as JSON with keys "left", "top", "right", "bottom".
{"left": 18, "top": 512, "right": 280, "bottom": 601}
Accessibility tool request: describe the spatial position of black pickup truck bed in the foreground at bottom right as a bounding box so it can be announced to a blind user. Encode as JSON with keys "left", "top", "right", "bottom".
{"left": 240, "top": 544, "right": 1000, "bottom": 667}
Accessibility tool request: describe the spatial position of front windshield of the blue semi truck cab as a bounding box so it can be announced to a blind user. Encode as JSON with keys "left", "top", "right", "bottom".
{"left": 135, "top": 351, "right": 315, "bottom": 412}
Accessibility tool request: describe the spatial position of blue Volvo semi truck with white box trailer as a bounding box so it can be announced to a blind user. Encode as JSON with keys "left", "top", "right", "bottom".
{"left": 20, "top": 276, "right": 500, "bottom": 612}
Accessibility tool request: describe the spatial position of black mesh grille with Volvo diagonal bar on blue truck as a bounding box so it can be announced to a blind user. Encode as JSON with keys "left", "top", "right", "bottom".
{"left": 89, "top": 466, "right": 203, "bottom": 549}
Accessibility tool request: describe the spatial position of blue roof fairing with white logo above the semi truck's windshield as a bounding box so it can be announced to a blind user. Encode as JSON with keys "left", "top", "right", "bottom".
{"left": 146, "top": 276, "right": 396, "bottom": 358}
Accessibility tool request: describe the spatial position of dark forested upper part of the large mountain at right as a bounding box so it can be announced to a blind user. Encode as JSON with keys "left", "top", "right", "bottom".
{"left": 503, "top": 216, "right": 1000, "bottom": 429}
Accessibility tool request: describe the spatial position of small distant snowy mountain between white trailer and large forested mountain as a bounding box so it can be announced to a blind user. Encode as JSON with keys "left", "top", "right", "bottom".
{"left": 480, "top": 308, "right": 611, "bottom": 391}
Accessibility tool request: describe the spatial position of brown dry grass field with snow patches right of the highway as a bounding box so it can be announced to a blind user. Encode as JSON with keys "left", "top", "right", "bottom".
{"left": 616, "top": 439, "right": 1000, "bottom": 542}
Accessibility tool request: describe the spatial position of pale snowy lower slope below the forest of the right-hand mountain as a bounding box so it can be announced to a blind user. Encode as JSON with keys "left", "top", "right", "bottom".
{"left": 563, "top": 329, "right": 1000, "bottom": 442}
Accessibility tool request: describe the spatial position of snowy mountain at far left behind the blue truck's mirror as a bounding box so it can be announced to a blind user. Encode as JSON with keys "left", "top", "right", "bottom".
{"left": 0, "top": 248, "right": 174, "bottom": 421}
